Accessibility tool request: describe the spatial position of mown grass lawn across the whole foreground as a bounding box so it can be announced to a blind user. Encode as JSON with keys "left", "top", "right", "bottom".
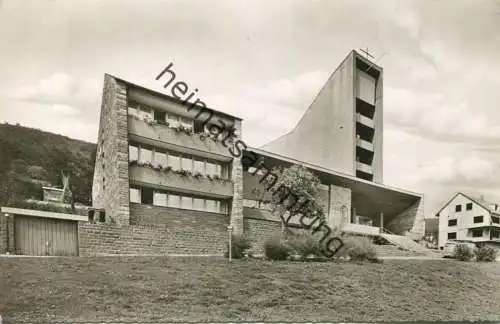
{"left": 0, "top": 257, "right": 500, "bottom": 322}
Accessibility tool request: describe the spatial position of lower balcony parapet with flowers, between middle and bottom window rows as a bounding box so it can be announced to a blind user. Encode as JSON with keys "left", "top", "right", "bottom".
{"left": 129, "top": 166, "right": 233, "bottom": 198}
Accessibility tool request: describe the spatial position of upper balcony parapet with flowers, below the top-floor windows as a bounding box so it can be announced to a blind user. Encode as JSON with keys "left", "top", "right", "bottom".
{"left": 128, "top": 116, "right": 232, "bottom": 161}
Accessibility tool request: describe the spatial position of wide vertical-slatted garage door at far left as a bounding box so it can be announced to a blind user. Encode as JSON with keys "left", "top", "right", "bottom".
{"left": 14, "top": 215, "right": 78, "bottom": 255}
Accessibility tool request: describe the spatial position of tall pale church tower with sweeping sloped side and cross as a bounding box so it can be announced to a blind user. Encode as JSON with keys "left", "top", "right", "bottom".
{"left": 262, "top": 51, "right": 383, "bottom": 183}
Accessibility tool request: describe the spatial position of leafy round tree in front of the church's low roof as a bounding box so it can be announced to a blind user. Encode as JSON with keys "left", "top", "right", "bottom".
{"left": 271, "top": 165, "right": 324, "bottom": 230}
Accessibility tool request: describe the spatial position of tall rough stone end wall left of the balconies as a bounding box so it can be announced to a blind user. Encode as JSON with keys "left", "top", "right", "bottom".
{"left": 92, "top": 75, "right": 129, "bottom": 225}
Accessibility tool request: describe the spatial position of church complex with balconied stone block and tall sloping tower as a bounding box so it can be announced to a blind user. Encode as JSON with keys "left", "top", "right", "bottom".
{"left": 84, "top": 51, "right": 424, "bottom": 254}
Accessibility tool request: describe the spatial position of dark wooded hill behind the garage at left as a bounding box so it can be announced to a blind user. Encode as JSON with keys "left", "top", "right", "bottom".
{"left": 0, "top": 123, "right": 96, "bottom": 206}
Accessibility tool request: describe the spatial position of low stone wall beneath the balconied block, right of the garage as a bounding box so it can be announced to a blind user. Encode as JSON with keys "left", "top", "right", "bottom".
{"left": 79, "top": 203, "right": 229, "bottom": 256}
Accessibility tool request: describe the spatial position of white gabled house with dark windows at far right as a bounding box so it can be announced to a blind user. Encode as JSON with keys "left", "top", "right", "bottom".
{"left": 436, "top": 193, "right": 500, "bottom": 248}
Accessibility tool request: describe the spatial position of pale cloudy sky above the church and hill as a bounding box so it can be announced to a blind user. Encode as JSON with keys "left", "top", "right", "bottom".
{"left": 0, "top": 0, "right": 500, "bottom": 217}
